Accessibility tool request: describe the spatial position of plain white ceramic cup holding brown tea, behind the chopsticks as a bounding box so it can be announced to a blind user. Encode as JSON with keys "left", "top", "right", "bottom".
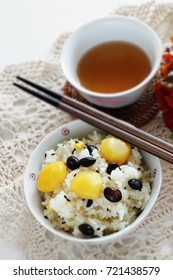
{"left": 61, "top": 16, "right": 162, "bottom": 108}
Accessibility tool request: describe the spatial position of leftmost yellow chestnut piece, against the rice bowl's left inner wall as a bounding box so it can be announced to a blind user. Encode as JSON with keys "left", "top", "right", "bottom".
{"left": 37, "top": 161, "right": 67, "bottom": 192}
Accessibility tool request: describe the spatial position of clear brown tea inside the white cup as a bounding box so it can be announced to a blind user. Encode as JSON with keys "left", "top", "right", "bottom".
{"left": 77, "top": 41, "right": 151, "bottom": 93}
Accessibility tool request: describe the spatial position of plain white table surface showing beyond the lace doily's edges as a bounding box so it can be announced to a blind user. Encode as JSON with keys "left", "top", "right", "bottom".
{"left": 0, "top": 0, "right": 171, "bottom": 260}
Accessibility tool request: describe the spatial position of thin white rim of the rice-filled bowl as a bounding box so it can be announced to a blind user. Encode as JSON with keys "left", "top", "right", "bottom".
{"left": 24, "top": 120, "right": 162, "bottom": 245}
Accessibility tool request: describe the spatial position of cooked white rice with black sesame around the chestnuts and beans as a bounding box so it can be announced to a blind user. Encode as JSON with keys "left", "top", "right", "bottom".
{"left": 39, "top": 131, "right": 152, "bottom": 238}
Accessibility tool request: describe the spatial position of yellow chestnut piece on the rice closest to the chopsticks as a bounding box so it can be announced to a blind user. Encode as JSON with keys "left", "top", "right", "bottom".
{"left": 100, "top": 137, "right": 131, "bottom": 165}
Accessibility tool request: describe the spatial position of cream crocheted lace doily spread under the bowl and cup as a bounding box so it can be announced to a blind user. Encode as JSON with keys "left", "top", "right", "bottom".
{"left": 0, "top": 1, "right": 173, "bottom": 259}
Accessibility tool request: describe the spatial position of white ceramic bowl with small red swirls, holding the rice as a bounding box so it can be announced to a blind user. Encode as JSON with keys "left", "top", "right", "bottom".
{"left": 24, "top": 120, "right": 162, "bottom": 244}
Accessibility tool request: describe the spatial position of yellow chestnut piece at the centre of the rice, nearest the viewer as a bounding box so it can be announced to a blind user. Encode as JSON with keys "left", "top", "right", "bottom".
{"left": 71, "top": 171, "right": 102, "bottom": 199}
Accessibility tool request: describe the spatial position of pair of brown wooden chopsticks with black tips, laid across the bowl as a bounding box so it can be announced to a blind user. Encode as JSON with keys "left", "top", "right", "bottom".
{"left": 13, "top": 76, "right": 173, "bottom": 163}
